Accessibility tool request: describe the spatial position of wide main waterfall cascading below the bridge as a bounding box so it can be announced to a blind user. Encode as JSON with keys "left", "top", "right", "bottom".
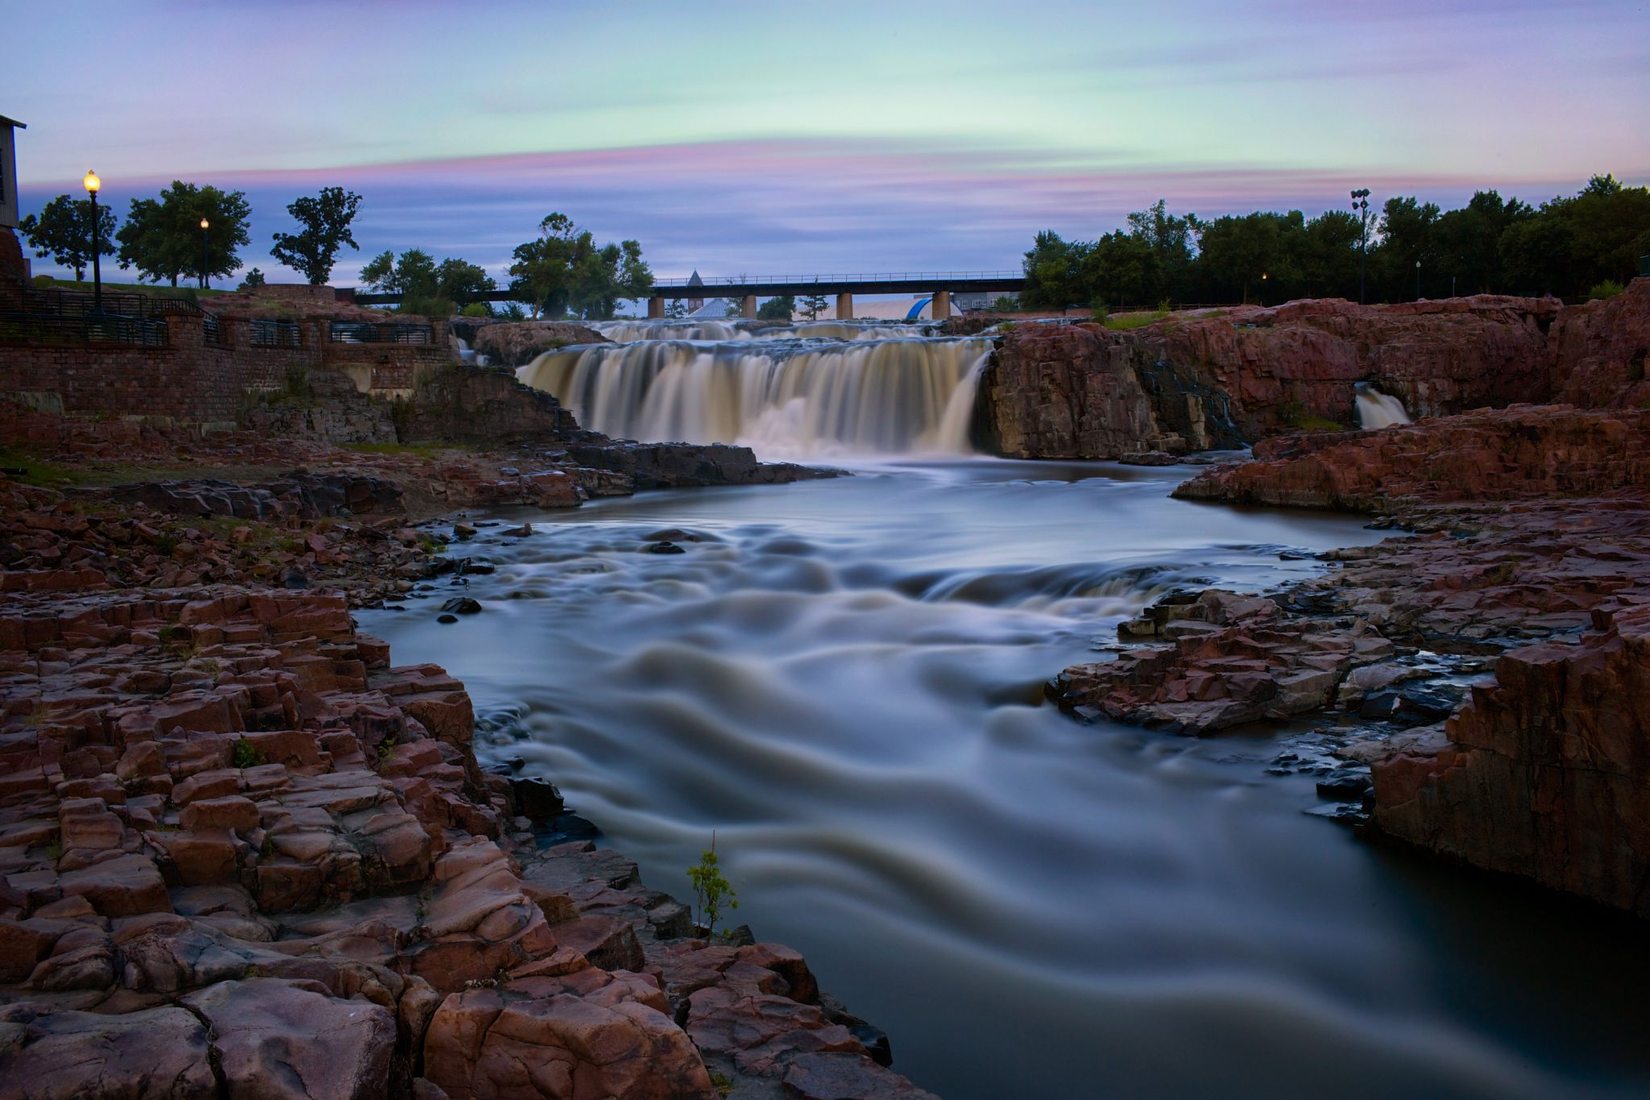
{"left": 516, "top": 333, "right": 992, "bottom": 458}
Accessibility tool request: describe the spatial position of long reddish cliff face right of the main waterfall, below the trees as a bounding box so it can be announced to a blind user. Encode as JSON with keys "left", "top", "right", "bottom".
{"left": 977, "top": 287, "right": 1577, "bottom": 458}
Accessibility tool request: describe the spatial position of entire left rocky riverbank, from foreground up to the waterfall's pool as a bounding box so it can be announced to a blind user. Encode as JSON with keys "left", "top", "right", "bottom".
{"left": 0, "top": 407, "right": 929, "bottom": 1100}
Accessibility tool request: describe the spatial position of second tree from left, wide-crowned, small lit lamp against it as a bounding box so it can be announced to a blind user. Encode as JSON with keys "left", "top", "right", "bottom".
{"left": 117, "top": 180, "right": 252, "bottom": 289}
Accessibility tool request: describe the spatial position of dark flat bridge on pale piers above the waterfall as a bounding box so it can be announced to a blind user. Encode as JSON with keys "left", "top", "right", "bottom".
{"left": 353, "top": 270, "right": 1026, "bottom": 322}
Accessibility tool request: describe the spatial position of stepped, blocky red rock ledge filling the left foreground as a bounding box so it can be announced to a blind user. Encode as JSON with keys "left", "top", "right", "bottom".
{"left": 0, "top": 571, "right": 927, "bottom": 1100}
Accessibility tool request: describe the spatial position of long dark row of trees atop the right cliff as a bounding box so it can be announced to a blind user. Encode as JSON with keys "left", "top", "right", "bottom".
{"left": 1021, "top": 175, "right": 1650, "bottom": 310}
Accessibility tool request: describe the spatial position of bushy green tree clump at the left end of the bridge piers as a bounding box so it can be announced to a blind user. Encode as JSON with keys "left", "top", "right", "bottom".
{"left": 510, "top": 213, "right": 653, "bottom": 320}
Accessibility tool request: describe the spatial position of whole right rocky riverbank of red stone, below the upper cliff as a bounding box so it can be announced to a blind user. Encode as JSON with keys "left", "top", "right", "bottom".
{"left": 1051, "top": 395, "right": 1650, "bottom": 915}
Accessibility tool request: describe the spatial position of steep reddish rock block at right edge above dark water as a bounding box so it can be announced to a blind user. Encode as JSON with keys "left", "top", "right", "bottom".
{"left": 1371, "top": 604, "right": 1650, "bottom": 917}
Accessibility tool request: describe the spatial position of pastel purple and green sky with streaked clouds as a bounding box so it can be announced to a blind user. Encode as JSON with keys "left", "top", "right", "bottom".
{"left": 0, "top": 0, "right": 1650, "bottom": 285}
